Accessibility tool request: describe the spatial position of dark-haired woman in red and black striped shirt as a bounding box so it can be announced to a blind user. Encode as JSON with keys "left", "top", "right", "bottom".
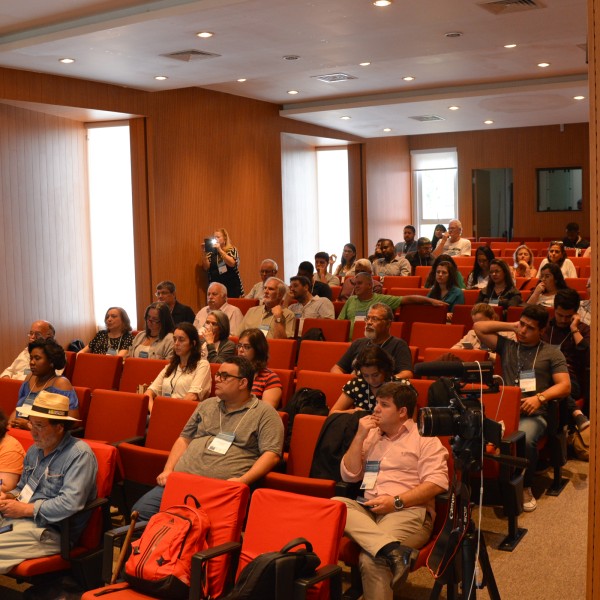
{"left": 237, "top": 329, "right": 283, "bottom": 408}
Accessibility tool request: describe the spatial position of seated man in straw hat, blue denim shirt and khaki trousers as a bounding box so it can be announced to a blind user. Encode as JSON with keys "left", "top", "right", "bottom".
{"left": 0, "top": 390, "right": 98, "bottom": 574}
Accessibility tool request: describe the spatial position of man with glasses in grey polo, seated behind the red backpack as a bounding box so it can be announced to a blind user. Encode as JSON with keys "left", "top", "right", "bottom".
{"left": 133, "top": 356, "right": 283, "bottom": 520}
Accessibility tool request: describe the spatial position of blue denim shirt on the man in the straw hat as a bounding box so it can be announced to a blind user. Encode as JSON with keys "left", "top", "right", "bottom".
{"left": 12, "top": 432, "right": 98, "bottom": 544}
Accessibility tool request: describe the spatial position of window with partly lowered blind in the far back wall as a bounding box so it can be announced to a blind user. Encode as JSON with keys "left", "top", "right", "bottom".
{"left": 411, "top": 148, "right": 458, "bottom": 239}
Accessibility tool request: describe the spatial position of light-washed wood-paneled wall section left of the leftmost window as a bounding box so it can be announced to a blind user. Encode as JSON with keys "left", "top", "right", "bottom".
{"left": 0, "top": 104, "right": 93, "bottom": 370}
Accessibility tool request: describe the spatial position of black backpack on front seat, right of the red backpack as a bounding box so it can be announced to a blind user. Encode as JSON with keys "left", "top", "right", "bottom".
{"left": 223, "top": 538, "right": 321, "bottom": 600}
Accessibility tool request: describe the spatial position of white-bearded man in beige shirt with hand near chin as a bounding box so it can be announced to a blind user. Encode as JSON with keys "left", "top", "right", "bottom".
{"left": 237, "top": 277, "right": 296, "bottom": 339}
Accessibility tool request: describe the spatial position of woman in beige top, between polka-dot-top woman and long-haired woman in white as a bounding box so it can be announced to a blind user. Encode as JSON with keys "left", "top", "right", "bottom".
{"left": 129, "top": 302, "right": 175, "bottom": 360}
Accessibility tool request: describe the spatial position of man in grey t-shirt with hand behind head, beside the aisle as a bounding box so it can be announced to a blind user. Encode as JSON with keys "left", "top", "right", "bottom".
{"left": 473, "top": 304, "right": 571, "bottom": 512}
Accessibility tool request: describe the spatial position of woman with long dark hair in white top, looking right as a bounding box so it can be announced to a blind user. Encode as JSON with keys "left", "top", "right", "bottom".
{"left": 146, "top": 323, "right": 212, "bottom": 412}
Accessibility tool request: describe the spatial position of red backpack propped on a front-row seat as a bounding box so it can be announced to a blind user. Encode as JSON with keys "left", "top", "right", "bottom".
{"left": 125, "top": 494, "right": 210, "bottom": 600}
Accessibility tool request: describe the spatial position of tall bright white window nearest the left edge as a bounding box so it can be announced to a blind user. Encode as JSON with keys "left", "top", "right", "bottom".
{"left": 88, "top": 124, "right": 137, "bottom": 327}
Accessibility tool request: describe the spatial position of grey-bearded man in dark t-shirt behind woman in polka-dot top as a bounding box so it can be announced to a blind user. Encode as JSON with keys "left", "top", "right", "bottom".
{"left": 331, "top": 302, "right": 413, "bottom": 379}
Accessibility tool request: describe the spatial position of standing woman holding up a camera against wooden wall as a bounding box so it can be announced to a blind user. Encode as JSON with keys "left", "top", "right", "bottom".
{"left": 202, "top": 228, "right": 244, "bottom": 298}
